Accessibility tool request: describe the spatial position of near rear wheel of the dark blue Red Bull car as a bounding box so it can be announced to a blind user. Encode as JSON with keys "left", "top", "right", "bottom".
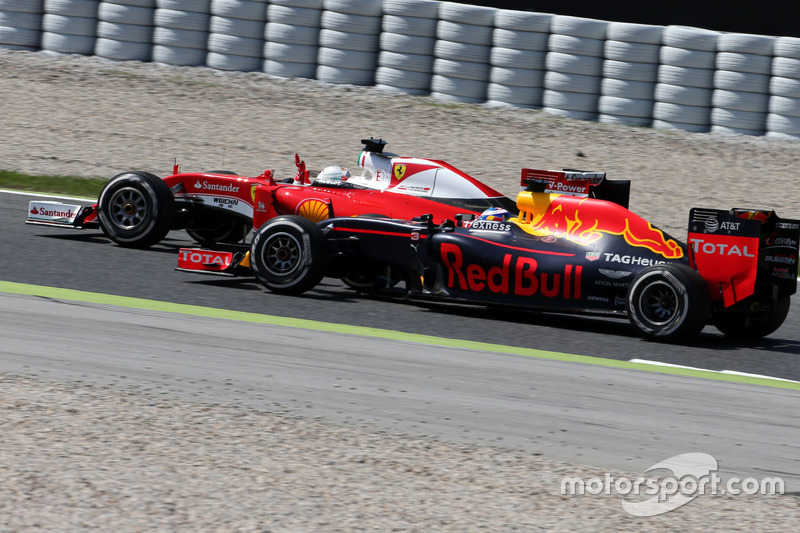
{"left": 628, "top": 264, "right": 711, "bottom": 342}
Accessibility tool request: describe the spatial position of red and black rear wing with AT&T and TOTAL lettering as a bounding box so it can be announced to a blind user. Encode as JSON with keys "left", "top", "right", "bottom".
{"left": 688, "top": 207, "right": 800, "bottom": 307}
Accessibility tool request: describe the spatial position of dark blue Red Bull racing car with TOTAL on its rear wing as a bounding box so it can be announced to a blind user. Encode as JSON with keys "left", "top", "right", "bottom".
{"left": 181, "top": 169, "right": 800, "bottom": 341}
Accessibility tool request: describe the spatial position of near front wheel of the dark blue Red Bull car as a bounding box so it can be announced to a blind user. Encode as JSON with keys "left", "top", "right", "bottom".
{"left": 250, "top": 215, "right": 329, "bottom": 294}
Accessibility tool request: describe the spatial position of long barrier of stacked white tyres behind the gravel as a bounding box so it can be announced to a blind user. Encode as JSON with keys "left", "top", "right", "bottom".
{"left": 0, "top": 0, "right": 800, "bottom": 139}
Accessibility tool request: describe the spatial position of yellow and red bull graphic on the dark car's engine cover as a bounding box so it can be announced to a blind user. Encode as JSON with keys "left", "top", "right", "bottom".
{"left": 517, "top": 192, "right": 683, "bottom": 259}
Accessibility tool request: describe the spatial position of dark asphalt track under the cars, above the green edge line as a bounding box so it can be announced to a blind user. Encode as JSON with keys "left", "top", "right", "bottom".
{"left": 0, "top": 189, "right": 800, "bottom": 381}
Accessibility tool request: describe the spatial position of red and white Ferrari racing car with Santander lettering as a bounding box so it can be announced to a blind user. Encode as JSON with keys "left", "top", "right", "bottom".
{"left": 27, "top": 138, "right": 514, "bottom": 248}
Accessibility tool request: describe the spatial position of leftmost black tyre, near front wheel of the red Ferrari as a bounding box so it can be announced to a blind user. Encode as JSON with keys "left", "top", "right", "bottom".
{"left": 97, "top": 172, "right": 175, "bottom": 248}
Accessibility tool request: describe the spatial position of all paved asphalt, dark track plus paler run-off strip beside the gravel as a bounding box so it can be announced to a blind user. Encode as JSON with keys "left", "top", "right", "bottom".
{"left": 0, "top": 189, "right": 800, "bottom": 491}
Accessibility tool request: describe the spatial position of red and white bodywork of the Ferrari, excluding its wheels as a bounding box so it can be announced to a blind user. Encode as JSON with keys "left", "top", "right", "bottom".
{"left": 84, "top": 152, "right": 506, "bottom": 228}
